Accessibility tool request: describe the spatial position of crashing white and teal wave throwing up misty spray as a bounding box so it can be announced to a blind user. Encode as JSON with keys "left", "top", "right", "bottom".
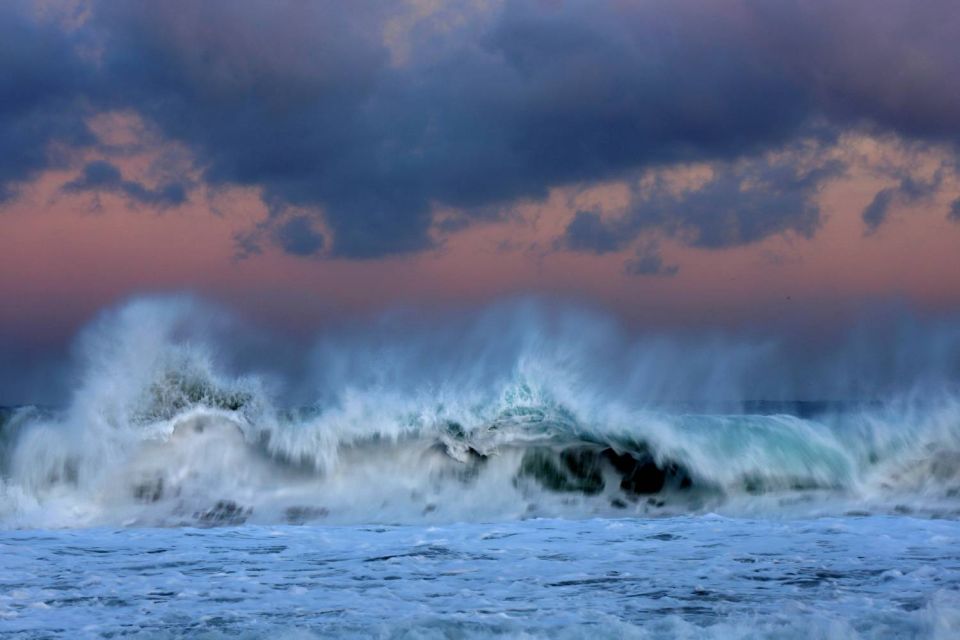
{"left": 0, "top": 298, "right": 960, "bottom": 527}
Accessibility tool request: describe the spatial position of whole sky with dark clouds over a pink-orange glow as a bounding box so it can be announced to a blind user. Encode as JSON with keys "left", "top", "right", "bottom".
{"left": 0, "top": 0, "right": 960, "bottom": 380}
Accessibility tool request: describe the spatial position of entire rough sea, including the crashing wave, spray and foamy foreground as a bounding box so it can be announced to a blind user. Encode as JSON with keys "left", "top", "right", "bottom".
{"left": 0, "top": 300, "right": 960, "bottom": 638}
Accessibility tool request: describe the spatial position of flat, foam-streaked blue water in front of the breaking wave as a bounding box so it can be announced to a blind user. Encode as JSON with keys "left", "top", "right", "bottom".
{"left": 0, "top": 515, "right": 960, "bottom": 638}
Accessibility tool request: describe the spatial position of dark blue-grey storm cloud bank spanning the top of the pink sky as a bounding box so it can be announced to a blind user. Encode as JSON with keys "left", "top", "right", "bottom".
{"left": 0, "top": 0, "right": 960, "bottom": 258}
